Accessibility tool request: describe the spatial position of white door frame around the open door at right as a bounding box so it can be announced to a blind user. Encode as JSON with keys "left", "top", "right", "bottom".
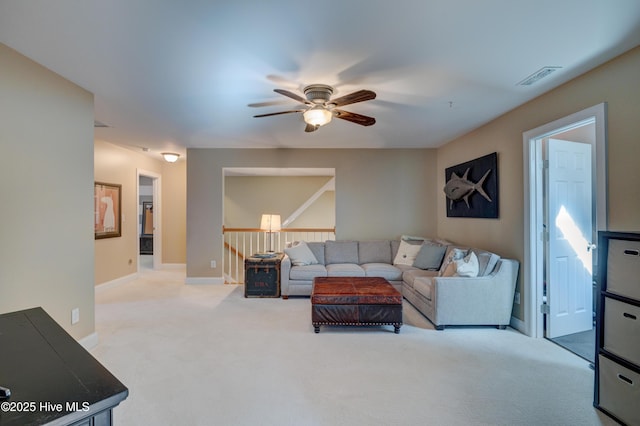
{"left": 517, "top": 102, "right": 608, "bottom": 338}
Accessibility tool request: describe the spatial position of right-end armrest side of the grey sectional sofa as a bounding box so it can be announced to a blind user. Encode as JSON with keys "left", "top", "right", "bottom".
{"left": 433, "top": 259, "right": 519, "bottom": 326}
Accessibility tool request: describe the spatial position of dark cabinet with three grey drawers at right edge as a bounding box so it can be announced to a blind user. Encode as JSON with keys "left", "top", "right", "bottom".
{"left": 593, "top": 232, "right": 640, "bottom": 425}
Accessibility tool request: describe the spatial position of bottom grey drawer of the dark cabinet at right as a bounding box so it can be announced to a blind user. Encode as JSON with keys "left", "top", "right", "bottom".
{"left": 598, "top": 355, "right": 640, "bottom": 425}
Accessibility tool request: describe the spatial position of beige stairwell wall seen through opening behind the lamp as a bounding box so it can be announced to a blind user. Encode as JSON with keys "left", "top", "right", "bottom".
{"left": 224, "top": 176, "right": 336, "bottom": 228}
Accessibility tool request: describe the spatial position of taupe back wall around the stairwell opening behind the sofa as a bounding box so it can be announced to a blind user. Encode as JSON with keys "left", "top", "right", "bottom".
{"left": 187, "top": 149, "right": 436, "bottom": 277}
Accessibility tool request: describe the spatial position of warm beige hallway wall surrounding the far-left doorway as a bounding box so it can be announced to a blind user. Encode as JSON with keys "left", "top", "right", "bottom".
{"left": 94, "top": 140, "right": 186, "bottom": 285}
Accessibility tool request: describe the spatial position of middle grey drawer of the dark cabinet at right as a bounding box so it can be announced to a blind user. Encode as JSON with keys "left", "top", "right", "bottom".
{"left": 604, "top": 297, "right": 640, "bottom": 365}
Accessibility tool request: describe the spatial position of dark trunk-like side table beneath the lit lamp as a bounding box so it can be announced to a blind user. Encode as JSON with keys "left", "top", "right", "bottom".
{"left": 244, "top": 253, "right": 284, "bottom": 297}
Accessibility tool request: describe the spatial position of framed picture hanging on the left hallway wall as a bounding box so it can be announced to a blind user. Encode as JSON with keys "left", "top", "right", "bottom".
{"left": 93, "top": 182, "right": 122, "bottom": 240}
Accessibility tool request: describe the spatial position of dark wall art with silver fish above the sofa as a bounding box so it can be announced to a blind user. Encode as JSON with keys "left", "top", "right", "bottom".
{"left": 443, "top": 152, "right": 498, "bottom": 218}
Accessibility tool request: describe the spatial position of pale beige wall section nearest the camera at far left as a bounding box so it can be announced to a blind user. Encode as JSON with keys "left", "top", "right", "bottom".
{"left": 0, "top": 44, "right": 95, "bottom": 339}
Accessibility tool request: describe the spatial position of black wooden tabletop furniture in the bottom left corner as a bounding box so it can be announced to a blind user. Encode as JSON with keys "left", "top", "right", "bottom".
{"left": 0, "top": 308, "right": 129, "bottom": 426}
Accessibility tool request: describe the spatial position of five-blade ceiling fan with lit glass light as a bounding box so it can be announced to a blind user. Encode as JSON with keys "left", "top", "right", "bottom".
{"left": 254, "top": 84, "right": 376, "bottom": 132}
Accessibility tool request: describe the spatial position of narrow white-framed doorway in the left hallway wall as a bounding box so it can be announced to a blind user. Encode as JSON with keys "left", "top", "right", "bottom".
{"left": 137, "top": 169, "right": 162, "bottom": 272}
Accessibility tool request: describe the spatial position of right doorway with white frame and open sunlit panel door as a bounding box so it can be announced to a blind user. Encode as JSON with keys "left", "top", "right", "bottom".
{"left": 523, "top": 103, "right": 607, "bottom": 361}
